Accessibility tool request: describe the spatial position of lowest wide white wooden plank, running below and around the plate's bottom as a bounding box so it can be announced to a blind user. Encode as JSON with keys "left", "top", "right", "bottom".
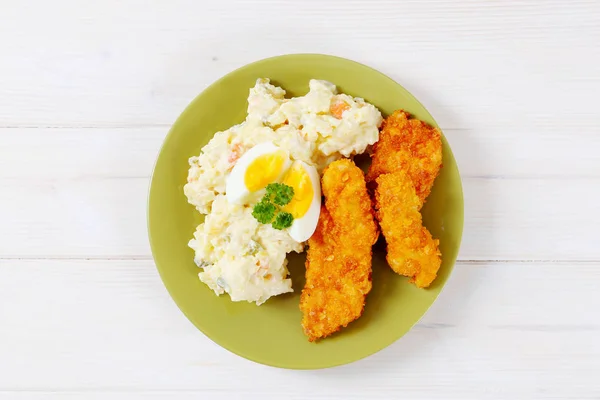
{"left": 0, "top": 260, "right": 600, "bottom": 399}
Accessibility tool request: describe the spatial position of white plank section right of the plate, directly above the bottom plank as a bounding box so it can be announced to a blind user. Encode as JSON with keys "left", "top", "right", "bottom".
{"left": 459, "top": 178, "right": 600, "bottom": 260}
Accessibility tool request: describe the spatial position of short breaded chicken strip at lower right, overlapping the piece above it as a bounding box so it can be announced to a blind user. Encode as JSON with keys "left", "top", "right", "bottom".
{"left": 375, "top": 171, "right": 442, "bottom": 288}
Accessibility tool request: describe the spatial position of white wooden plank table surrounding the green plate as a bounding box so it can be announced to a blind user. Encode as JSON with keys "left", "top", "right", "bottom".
{"left": 0, "top": 0, "right": 600, "bottom": 400}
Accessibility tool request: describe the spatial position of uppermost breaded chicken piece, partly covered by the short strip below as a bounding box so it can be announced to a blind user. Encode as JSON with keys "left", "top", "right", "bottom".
{"left": 367, "top": 110, "right": 442, "bottom": 202}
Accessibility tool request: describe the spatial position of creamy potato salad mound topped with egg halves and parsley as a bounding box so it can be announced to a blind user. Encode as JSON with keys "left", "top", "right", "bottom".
{"left": 184, "top": 79, "right": 382, "bottom": 305}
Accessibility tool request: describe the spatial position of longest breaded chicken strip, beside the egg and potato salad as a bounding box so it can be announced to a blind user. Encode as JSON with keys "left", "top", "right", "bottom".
{"left": 300, "top": 159, "right": 377, "bottom": 342}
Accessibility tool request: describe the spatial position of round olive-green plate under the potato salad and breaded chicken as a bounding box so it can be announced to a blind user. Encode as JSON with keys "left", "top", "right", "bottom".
{"left": 148, "top": 54, "right": 463, "bottom": 369}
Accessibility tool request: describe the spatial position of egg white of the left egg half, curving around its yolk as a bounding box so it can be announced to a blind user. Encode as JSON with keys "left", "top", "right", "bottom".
{"left": 225, "top": 142, "right": 292, "bottom": 204}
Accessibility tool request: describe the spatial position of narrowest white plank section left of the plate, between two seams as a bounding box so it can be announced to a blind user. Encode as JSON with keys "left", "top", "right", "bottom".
{"left": 0, "top": 127, "right": 166, "bottom": 180}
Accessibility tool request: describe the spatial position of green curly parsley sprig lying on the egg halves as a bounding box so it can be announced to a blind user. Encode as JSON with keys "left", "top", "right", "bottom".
{"left": 252, "top": 183, "right": 294, "bottom": 230}
